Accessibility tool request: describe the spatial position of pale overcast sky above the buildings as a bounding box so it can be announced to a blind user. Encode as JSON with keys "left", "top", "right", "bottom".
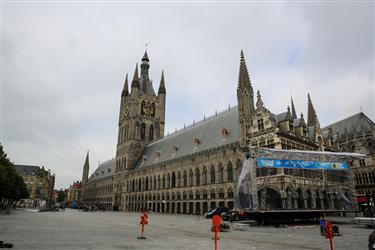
{"left": 0, "top": 1, "right": 375, "bottom": 188}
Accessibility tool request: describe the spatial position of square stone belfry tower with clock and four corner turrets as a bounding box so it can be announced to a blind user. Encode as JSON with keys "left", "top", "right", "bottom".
{"left": 116, "top": 51, "right": 166, "bottom": 173}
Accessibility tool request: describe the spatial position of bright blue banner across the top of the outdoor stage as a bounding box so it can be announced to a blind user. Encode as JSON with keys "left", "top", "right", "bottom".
{"left": 257, "top": 158, "right": 348, "bottom": 170}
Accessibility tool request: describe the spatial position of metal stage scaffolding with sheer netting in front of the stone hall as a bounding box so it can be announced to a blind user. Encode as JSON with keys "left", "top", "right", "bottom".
{"left": 234, "top": 148, "right": 365, "bottom": 211}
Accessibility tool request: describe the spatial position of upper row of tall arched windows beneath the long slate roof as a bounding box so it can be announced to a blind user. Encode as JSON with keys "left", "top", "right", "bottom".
{"left": 126, "top": 159, "right": 242, "bottom": 192}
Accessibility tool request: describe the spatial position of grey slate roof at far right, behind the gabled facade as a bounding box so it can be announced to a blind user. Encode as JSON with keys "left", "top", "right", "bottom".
{"left": 322, "top": 112, "right": 375, "bottom": 135}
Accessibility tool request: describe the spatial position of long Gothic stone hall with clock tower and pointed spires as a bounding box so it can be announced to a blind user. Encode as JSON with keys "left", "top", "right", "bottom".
{"left": 83, "top": 51, "right": 375, "bottom": 214}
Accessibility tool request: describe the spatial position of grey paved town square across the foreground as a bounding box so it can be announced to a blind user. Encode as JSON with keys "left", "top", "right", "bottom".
{"left": 0, "top": 209, "right": 372, "bottom": 250}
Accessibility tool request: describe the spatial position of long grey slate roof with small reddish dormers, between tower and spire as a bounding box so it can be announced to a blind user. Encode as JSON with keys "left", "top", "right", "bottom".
{"left": 136, "top": 107, "right": 240, "bottom": 168}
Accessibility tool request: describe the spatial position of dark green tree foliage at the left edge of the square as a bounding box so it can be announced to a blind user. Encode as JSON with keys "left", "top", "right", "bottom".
{"left": 0, "top": 144, "right": 29, "bottom": 204}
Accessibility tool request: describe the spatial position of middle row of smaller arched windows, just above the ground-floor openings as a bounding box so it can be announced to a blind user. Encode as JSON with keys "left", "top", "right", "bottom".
{"left": 125, "top": 187, "right": 233, "bottom": 201}
